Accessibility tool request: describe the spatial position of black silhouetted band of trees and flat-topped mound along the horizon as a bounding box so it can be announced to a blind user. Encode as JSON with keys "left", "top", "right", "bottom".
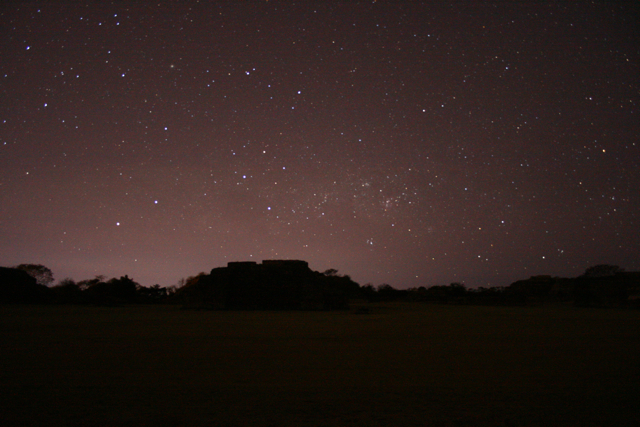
{"left": 0, "top": 261, "right": 640, "bottom": 310}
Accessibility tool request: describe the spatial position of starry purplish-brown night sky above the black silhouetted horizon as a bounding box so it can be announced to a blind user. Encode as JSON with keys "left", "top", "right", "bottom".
{"left": 0, "top": 0, "right": 640, "bottom": 289}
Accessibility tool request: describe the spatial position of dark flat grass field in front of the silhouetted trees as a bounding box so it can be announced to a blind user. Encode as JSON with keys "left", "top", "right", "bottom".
{"left": 0, "top": 304, "right": 640, "bottom": 426}
